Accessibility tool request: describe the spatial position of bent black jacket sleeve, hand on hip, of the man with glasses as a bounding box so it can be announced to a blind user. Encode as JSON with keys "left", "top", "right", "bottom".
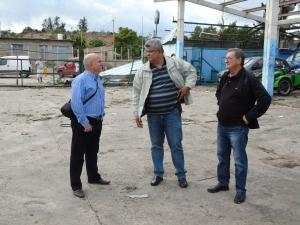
{"left": 245, "top": 78, "right": 272, "bottom": 122}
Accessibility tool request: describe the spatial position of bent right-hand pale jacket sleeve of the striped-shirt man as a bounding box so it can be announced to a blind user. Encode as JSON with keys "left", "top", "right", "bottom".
{"left": 176, "top": 58, "right": 197, "bottom": 88}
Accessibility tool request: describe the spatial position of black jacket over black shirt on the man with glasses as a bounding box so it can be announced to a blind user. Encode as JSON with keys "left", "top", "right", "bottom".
{"left": 216, "top": 68, "right": 271, "bottom": 129}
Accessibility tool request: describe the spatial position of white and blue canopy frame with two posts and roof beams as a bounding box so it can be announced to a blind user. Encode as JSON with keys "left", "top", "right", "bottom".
{"left": 154, "top": 0, "right": 300, "bottom": 95}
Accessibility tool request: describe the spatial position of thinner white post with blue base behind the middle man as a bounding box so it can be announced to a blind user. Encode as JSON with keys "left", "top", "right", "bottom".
{"left": 176, "top": 0, "right": 185, "bottom": 58}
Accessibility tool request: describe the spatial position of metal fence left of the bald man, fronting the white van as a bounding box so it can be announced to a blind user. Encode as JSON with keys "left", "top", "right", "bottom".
{"left": 0, "top": 56, "right": 79, "bottom": 87}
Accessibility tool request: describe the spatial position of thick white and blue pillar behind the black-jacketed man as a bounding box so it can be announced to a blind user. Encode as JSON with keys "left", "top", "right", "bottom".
{"left": 262, "top": 0, "right": 279, "bottom": 96}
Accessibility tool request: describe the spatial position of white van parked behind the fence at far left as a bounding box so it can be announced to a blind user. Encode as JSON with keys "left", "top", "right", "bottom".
{"left": 0, "top": 56, "right": 32, "bottom": 77}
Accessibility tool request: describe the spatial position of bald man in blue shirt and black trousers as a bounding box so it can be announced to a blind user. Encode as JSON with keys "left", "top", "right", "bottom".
{"left": 70, "top": 53, "right": 110, "bottom": 198}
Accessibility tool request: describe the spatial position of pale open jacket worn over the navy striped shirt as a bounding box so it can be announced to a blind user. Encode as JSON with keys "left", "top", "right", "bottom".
{"left": 133, "top": 56, "right": 197, "bottom": 117}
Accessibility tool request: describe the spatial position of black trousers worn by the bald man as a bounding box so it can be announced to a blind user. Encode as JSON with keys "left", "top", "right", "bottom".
{"left": 70, "top": 118, "right": 102, "bottom": 191}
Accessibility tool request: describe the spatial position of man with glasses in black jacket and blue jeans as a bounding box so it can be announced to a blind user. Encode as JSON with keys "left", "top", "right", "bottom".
{"left": 207, "top": 48, "right": 271, "bottom": 204}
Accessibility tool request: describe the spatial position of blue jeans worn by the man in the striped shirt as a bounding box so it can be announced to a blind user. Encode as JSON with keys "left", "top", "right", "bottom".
{"left": 147, "top": 109, "right": 186, "bottom": 179}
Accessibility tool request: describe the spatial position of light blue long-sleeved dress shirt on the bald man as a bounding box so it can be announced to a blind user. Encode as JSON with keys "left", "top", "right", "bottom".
{"left": 71, "top": 70, "right": 105, "bottom": 127}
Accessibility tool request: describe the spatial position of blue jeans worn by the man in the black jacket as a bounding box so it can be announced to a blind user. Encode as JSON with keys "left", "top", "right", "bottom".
{"left": 217, "top": 124, "right": 249, "bottom": 192}
